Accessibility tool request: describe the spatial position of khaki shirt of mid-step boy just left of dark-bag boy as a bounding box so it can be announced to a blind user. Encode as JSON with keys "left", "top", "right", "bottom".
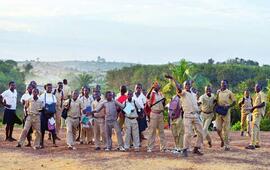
{"left": 199, "top": 94, "right": 216, "bottom": 113}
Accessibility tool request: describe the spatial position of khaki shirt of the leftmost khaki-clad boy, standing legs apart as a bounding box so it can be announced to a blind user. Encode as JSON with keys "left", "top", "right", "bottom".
{"left": 26, "top": 97, "right": 43, "bottom": 115}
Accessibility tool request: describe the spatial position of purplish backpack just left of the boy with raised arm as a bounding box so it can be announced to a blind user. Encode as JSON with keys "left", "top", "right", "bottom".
{"left": 169, "top": 95, "right": 183, "bottom": 119}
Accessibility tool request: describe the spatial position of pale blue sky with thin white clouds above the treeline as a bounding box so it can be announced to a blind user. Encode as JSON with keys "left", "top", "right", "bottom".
{"left": 0, "top": 0, "right": 270, "bottom": 64}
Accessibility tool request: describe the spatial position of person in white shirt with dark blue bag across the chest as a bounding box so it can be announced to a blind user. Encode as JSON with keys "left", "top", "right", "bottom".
{"left": 40, "top": 83, "right": 57, "bottom": 148}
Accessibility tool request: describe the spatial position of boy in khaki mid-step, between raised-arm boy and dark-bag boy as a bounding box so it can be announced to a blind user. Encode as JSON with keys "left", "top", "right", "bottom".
{"left": 198, "top": 86, "right": 216, "bottom": 148}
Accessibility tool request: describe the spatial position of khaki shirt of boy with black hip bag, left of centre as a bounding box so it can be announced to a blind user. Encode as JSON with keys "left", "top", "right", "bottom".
{"left": 64, "top": 99, "right": 82, "bottom": 118}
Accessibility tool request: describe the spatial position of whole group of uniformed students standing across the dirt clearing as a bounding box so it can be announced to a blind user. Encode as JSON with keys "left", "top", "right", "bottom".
{"left": 0, "top": 75, "right": 266, "bottom": 157}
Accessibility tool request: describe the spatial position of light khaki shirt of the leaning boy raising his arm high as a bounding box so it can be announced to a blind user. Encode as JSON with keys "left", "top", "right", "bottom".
{"left": 178, "top": 90, "right": 199, "bottom": 113}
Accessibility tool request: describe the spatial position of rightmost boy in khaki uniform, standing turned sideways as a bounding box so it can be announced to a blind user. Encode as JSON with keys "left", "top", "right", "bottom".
{"left": 246, "top": 84, "right": 266, "bottom": 149}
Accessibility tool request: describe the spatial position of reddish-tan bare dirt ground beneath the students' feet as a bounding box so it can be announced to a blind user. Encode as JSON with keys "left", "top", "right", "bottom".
{"left": 0, "top": 128, "right": 270, "bottom": 170}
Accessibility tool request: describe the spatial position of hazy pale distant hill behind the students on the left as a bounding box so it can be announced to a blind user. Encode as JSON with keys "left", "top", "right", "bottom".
{"left": 18, "top": 58, "right": 135, "bottom": 84}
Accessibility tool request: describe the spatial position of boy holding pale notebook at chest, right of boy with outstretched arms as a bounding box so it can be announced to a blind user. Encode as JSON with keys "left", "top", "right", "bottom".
{"left": 123, "top": 90, "right": 141, "bottom": 152}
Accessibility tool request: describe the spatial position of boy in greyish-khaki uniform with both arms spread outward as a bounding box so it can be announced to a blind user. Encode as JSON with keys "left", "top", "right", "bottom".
{"left": 92, "top": 91, "right": 125, "bottom": 151}
